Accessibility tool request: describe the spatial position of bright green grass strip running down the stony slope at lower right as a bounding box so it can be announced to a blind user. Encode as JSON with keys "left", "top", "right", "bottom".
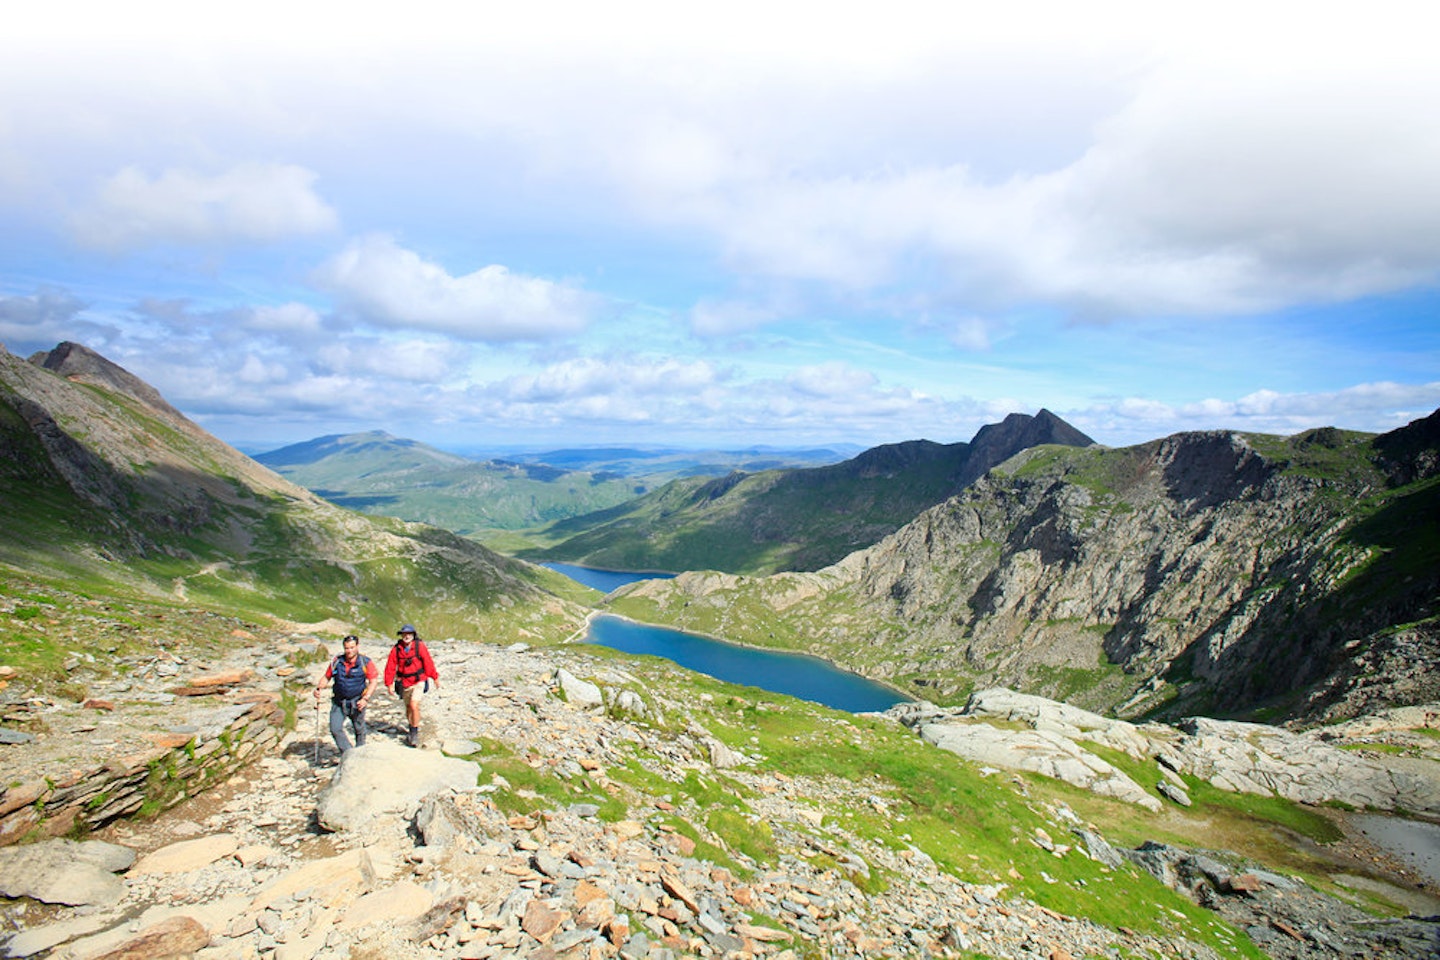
{"left": 639, "top": 678, "right": 1263, "bottom": 957}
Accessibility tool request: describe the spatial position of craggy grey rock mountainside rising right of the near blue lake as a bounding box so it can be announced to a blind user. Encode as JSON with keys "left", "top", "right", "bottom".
{"left": 613, "top": 412, "right": 1440, "bottom": 718}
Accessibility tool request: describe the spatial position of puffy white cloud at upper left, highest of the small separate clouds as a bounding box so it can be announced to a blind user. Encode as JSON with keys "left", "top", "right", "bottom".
{"left": 71, "top": 164, "right": 338, "bottom": 250}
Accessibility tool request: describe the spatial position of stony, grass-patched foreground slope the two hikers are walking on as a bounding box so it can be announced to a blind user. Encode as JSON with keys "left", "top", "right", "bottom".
{"left": 0, "top": 624, "right": 1437, "bottom": 960}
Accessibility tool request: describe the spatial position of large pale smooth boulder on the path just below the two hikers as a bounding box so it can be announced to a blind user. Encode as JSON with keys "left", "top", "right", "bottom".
{"left": 317, "top": 740, "right": 480, "bottom": 832}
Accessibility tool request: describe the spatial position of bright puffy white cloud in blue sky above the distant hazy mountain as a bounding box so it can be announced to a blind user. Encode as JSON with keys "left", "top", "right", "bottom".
{"left": 315, "top": 233, "right": 596, "bottom": 341}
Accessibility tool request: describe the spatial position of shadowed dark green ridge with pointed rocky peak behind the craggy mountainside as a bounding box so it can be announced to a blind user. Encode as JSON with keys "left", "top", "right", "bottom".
{"left": 521, "top": 410, "right": 1093, "bottom": 573}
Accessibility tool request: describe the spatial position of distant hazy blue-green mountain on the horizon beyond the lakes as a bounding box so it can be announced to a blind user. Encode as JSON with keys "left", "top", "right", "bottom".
{"left": 255, "top": 432, "right": 649, "bottom": 538}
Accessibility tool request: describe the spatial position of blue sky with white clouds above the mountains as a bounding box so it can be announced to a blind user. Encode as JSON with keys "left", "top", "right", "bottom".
{"left": 0, "top": 0, "right": 1440, "bottom": 450}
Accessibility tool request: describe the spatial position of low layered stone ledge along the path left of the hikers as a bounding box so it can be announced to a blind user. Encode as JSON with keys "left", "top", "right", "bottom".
{"left": 0, "top": 692, "right": 285, "bottom": 846}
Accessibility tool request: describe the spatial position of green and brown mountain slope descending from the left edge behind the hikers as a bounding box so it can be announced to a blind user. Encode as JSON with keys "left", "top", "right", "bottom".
{"left": 0, "top": 343, "right": 577, "bottom": 636}
